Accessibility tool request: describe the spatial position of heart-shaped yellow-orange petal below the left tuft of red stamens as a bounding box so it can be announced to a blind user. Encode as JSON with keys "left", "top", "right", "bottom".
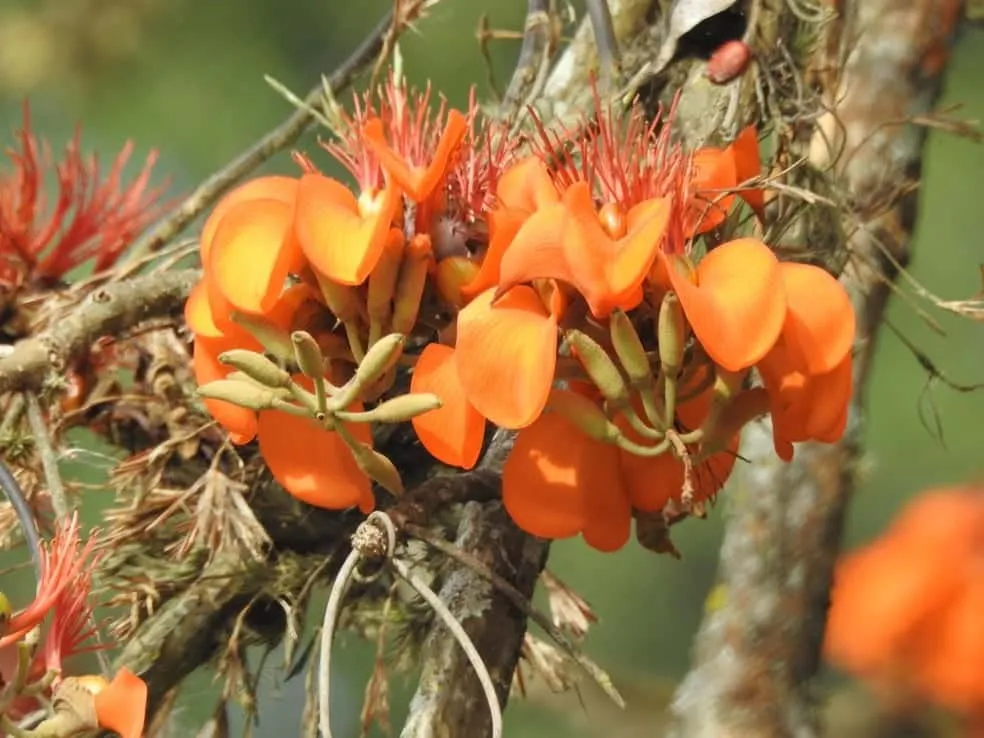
{"left": 294, "top": 174, "right": 400, "bottom": 285}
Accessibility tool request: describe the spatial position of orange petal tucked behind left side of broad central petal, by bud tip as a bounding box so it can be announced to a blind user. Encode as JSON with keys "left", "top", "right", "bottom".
{"left": 410, "top": 343, "right": 485, "bottom": 469}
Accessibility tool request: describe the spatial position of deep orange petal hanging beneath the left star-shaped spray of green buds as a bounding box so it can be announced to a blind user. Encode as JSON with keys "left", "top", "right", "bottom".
{"left": 257, "top": 408, "right": 374, "bottom": 512}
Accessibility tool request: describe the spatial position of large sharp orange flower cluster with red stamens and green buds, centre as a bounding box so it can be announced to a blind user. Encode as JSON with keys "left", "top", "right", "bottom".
{"left": 186, "top": 72, "right": 855, "bottom": 551}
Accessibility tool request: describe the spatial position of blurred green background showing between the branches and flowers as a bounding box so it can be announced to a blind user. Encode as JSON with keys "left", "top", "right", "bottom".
{"left": 0, "top": 0, "right": 984, "bottom": 738}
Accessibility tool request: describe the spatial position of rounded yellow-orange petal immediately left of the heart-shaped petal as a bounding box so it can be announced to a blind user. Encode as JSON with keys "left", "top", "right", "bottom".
{"left": 205, "top": 199, "right": 301, "bottom": 315}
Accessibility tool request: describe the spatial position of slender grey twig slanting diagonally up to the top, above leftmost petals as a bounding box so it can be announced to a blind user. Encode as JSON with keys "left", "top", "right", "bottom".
{"left": 117, "top": 11, "right": 393, "bottom": 264}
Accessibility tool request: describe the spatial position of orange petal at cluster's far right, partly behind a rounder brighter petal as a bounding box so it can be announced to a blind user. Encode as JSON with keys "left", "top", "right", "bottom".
{"left": 780, "top": 262, "right": 855, "bottom": 374}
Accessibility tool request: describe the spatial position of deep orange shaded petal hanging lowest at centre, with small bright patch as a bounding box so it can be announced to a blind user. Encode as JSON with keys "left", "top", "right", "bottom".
{"left": 502, "top": 413, "right": 588, "bottom": 539}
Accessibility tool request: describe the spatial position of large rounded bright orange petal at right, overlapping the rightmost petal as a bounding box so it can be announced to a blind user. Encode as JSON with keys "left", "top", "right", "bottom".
{"left": 662, "top": 238, "right": 786, "bottom": 371}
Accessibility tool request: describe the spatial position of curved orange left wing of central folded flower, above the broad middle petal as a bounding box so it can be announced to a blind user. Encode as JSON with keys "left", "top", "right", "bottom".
{"left": 499, "top": 203, "right": 572, "bottom": 294}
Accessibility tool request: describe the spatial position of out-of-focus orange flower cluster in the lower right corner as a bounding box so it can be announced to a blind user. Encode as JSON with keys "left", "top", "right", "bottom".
{"left": 825, "top": 488, "right": 984, "bottom": 717}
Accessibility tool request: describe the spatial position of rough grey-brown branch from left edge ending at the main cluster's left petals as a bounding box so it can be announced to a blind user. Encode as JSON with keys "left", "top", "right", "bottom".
{"left": 0, "top": 269, "right": 200, "bottom": 394}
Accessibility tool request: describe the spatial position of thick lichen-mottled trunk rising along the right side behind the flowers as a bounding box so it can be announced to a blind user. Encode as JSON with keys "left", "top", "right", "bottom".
{"left": 673, "top": 0, "right": 961, "bottom": 738}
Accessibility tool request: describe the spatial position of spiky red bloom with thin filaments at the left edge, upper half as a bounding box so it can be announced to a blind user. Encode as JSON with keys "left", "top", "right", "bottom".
{"left": 0, "top": 102, "right": 164, "bottom": 287}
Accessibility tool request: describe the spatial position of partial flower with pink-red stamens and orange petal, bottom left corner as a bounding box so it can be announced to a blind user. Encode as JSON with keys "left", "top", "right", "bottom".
{"left": 0, "top": 516, "right": 147, "bottom": 738}
